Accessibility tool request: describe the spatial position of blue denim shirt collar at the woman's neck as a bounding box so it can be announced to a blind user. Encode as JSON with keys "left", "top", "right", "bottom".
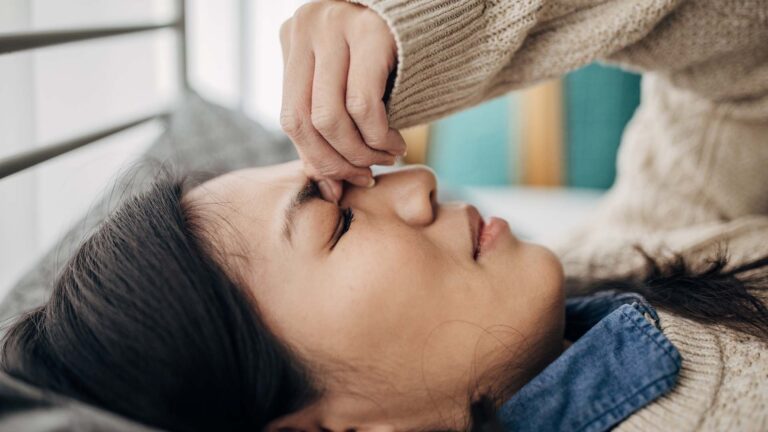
{"left": 497, "top": 292, "right": 681, "bottom": 432}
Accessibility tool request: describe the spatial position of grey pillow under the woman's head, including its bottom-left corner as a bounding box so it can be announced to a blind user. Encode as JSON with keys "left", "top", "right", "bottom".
{"left": 0, "top": 93, "right": 297, "bottom": 432}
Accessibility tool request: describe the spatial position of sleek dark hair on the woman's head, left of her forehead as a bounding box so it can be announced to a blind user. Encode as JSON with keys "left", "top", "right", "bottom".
{"left": 0, "top": 179, "right": 318, "bottom": 431}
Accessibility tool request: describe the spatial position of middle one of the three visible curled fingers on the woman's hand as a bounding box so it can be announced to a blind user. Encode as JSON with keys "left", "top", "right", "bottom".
{"left": 311, "top": 33, "right": 395, "bottom": 167}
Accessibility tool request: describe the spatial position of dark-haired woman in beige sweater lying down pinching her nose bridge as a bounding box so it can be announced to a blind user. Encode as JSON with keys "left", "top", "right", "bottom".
{"left": 3, "top": 0, "right": 768, "bottom": 431}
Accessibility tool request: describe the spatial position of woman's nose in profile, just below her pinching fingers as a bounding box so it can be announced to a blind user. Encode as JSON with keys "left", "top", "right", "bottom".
{"left": 350, "top": 165, "right": 437, "bottom": 226}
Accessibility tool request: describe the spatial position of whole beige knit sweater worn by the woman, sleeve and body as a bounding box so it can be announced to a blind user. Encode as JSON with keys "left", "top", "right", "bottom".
{"left": 349, "top": 0, "right": 768, "bottom": 431}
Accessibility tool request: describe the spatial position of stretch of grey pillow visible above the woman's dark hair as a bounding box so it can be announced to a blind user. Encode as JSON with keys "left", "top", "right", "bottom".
{"left": 0, "top": 93, "right": 297, "bottom": 328}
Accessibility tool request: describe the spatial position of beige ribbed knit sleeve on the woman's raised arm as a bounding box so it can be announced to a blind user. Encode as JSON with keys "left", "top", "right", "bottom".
{"left": 349, "top": 0, "right": 682, "bottom": 128}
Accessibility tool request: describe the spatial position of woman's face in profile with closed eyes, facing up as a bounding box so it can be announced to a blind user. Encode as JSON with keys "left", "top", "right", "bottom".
{"left": 186, "top": 162, "right": 563, "bottom": 427}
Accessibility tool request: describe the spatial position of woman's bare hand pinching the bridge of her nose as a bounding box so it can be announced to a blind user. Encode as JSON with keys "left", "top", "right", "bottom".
{"left": 280, "top": 0, "right": 405, "bottom": 201}
